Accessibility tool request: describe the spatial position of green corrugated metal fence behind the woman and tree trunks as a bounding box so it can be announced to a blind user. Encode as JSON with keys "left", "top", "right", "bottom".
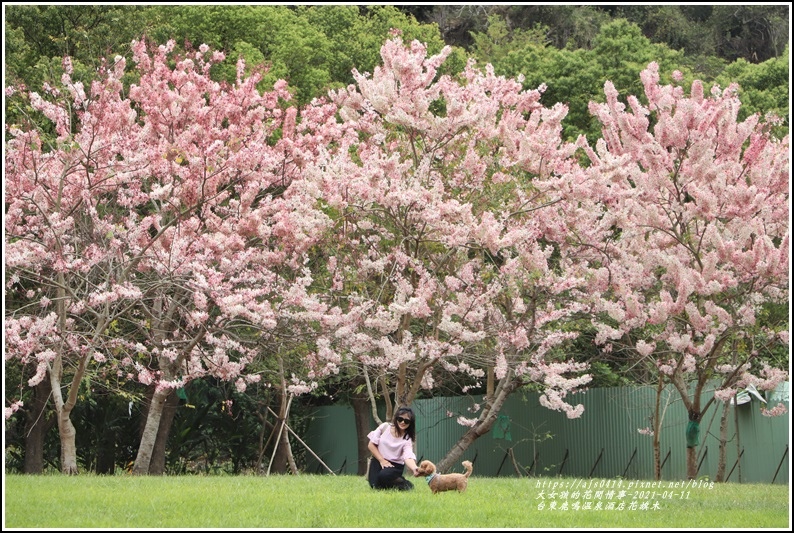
{"left": 306, "top": 387, "right": 790, "bottom": 484}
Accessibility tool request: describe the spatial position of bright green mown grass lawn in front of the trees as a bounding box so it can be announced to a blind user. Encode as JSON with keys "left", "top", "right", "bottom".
{"left": 3, "top": 474, "right": 791, "bottom": 530}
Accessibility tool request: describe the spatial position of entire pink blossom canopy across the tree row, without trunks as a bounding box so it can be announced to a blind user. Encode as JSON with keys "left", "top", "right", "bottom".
{"left": 4, "top": 36, "right": 790, "bottom": 432}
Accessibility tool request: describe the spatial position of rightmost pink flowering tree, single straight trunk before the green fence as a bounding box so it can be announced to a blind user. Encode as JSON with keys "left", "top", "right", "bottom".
{"left": 582, "top": 63, "right": 790, "bottom": 477}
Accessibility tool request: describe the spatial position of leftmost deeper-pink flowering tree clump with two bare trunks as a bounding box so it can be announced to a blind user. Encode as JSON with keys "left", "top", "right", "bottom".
{"left": 5, "top": 42, "right": 333, "bottom": 473}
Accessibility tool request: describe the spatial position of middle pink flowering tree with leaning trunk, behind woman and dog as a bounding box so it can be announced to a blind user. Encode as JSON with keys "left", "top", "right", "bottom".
{"left": 300, "top": 37, "right": 594, "bottom": 470}
